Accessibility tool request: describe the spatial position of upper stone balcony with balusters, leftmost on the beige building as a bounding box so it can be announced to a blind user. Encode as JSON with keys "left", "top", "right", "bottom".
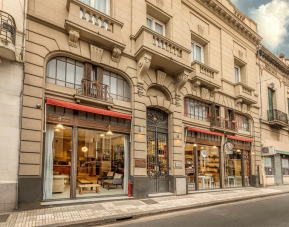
{"left": 65, "top": 0, "right": 125, "bottom": 51}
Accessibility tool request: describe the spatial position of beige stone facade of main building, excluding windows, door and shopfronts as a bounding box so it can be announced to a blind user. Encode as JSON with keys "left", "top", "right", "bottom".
{"left": 19, "top": 0, "right": 264, "bottom": 210}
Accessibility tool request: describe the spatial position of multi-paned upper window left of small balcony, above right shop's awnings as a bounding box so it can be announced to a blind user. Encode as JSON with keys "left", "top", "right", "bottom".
{"left": 184, "top": 98, "right": 210, "bottom": 121}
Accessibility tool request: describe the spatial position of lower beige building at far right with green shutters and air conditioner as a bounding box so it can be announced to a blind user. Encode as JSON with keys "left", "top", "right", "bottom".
{"left": 258, "top": 45, "right": 289, "bottom": 185}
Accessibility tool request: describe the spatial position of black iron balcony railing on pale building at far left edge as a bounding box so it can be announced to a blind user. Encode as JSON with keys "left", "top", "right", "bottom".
{"left": 0, "top": 10, "right": 16, "bottom": 45}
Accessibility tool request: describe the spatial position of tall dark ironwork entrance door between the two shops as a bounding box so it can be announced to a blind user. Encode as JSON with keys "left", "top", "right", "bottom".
{"left": 147, "top": 108, "right": 169, "bottom": 194}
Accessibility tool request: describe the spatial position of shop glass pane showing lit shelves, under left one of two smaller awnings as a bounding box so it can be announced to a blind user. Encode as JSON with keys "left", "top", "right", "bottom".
{"left": 197, "top": 145, "right": 220, "bottom": 189}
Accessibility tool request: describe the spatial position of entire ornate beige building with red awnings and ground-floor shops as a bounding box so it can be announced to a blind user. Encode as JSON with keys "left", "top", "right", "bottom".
{"left": 19, "top": 0, "right": 261, "bottom": 208}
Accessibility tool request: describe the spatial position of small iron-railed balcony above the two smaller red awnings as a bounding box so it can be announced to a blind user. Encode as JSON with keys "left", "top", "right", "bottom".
{"left": 210, "top": 117, "right": 238, "bottom": 134}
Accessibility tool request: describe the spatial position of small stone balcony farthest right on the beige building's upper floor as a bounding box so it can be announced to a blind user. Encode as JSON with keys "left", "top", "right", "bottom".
{"left": 235, "top": 82, "right": 257, "bottom": 105}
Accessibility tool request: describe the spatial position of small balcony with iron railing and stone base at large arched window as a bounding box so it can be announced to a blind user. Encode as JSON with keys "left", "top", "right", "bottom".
{"left": 75, "top": 79, "right": 113, "bottom": 109}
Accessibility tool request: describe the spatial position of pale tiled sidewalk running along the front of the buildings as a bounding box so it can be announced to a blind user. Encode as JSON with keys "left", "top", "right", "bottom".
{"left": 0, "top": 185, "right": 289, "bottom": 227}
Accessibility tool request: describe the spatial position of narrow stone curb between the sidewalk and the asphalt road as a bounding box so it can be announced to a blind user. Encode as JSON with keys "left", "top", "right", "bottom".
{"left": 44, "top": 190, "right": 289, "bottom": 227}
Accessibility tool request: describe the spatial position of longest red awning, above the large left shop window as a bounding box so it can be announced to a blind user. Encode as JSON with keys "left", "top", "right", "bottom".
{"left": 46, "top": 98, "right": 131, "bottom": 119}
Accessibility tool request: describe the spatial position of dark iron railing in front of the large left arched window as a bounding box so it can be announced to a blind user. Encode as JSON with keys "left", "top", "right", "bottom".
{"left": 79, "top": 79, "right": 113, "bottom": 102}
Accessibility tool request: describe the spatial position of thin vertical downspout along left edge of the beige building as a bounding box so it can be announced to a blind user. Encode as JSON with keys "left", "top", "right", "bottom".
{"left": 16, "top": 0, "right": 26, "bottom": 210}
